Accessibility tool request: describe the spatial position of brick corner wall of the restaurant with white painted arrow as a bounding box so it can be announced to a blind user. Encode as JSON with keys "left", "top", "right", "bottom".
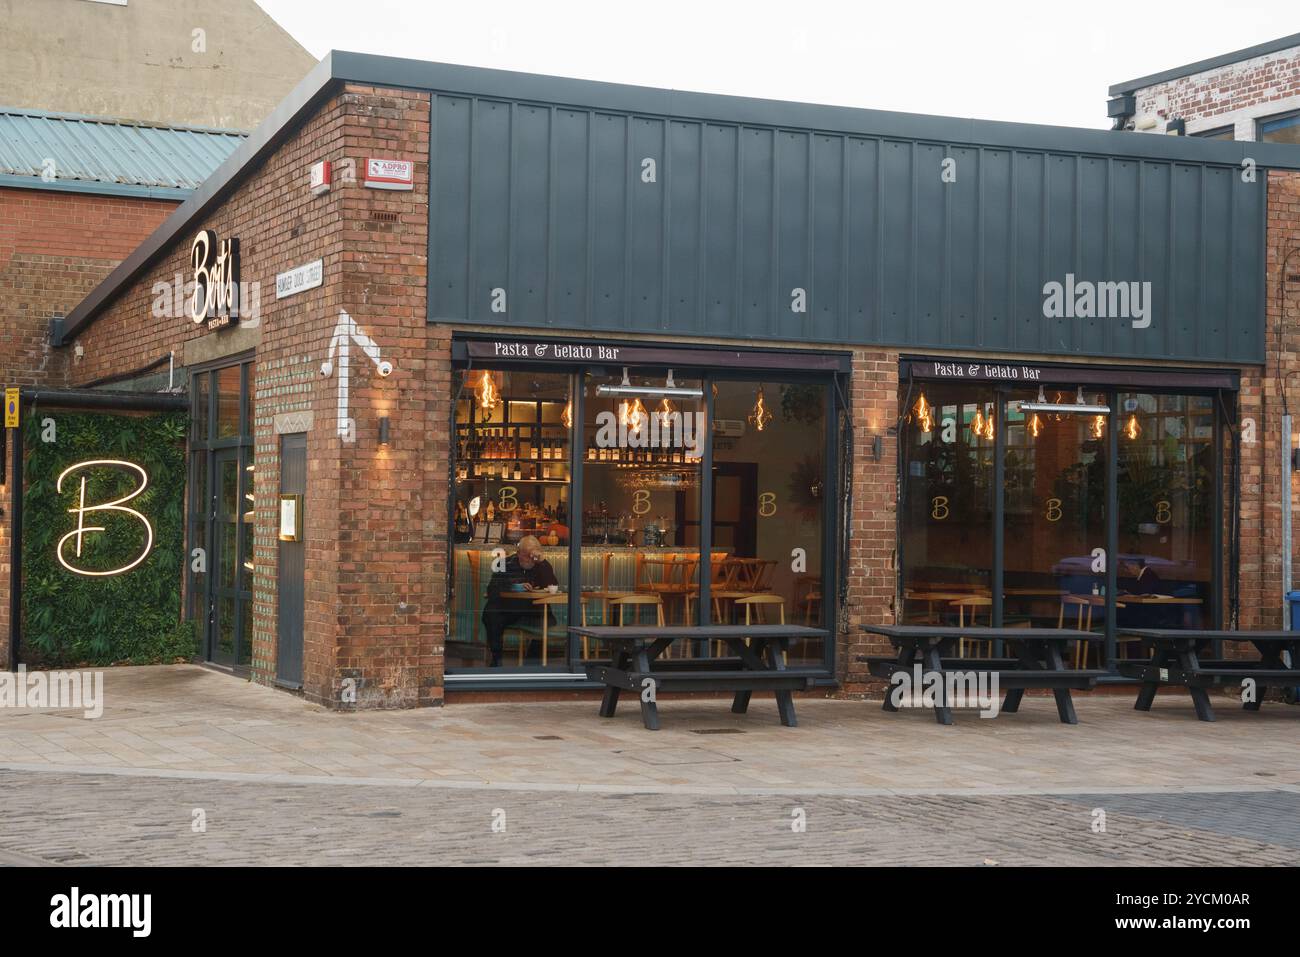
{"left": 52, "top": 86, "right": 441, "bottom": 707}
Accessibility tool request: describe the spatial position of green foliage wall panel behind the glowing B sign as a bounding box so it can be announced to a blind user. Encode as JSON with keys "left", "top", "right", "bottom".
{"left": 22, "top": 410, "right": 194, "bottom": 666}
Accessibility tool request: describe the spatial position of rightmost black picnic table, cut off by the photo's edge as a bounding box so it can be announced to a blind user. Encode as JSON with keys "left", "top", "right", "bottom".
{"left": 1118, "top": 628, "right": 1300, "bottom": 722}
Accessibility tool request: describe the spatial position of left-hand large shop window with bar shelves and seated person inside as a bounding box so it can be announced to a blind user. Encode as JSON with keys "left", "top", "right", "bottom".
{"left": 447, "top": 356, "right": 835, "bottom": 677}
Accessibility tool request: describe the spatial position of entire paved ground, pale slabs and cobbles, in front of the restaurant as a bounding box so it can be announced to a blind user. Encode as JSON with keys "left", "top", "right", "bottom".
{"left": 0, "top": 666, "right": 1300, "bottom": 866}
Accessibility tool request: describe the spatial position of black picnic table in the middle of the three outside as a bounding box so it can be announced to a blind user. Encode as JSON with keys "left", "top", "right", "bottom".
{"left": 862, "top": 624, "right": 1108, "bottom": 724}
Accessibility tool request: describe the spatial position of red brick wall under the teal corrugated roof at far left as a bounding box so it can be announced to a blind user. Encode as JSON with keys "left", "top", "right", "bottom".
{"left": 0, "top": 187, "right": 177, "bottom": 663}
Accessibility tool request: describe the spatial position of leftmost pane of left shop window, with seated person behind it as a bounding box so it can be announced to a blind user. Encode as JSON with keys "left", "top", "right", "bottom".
{"left": 447, "top": 369, "right": 572, "bottom": 671}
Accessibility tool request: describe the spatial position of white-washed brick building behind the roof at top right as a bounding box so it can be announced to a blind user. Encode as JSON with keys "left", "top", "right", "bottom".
{"left": 1108, "top": 34, "right": 1300, "bottom": 144}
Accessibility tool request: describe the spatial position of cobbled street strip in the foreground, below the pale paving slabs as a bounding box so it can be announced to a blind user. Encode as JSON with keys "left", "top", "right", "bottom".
{"left": 0, "top": 771, "right": 1300, "bottom": 866}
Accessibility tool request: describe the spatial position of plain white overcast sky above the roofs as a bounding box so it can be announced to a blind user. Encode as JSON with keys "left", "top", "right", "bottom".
{"left": 248, "top": 0, "right": 1300, "bottom": 129}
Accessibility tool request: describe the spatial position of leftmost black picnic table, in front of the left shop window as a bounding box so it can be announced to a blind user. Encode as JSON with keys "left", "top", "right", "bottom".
{"left": 569, "top": 624, "right": 829, "bottom": 731}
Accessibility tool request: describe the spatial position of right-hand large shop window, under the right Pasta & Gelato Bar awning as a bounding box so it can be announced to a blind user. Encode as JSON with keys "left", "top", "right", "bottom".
{"left": 898, "top": 381, "right": 1218, "bottom": 664}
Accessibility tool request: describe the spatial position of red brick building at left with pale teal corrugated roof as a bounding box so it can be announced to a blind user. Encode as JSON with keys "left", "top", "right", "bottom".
{"left": 0, "top": 108, "right": 243, "bottom": 657}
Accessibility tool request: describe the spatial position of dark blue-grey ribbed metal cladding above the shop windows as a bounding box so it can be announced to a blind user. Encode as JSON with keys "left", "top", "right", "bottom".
{"left": 429, "top": 94, "right": 1266, "bottom": 361}
